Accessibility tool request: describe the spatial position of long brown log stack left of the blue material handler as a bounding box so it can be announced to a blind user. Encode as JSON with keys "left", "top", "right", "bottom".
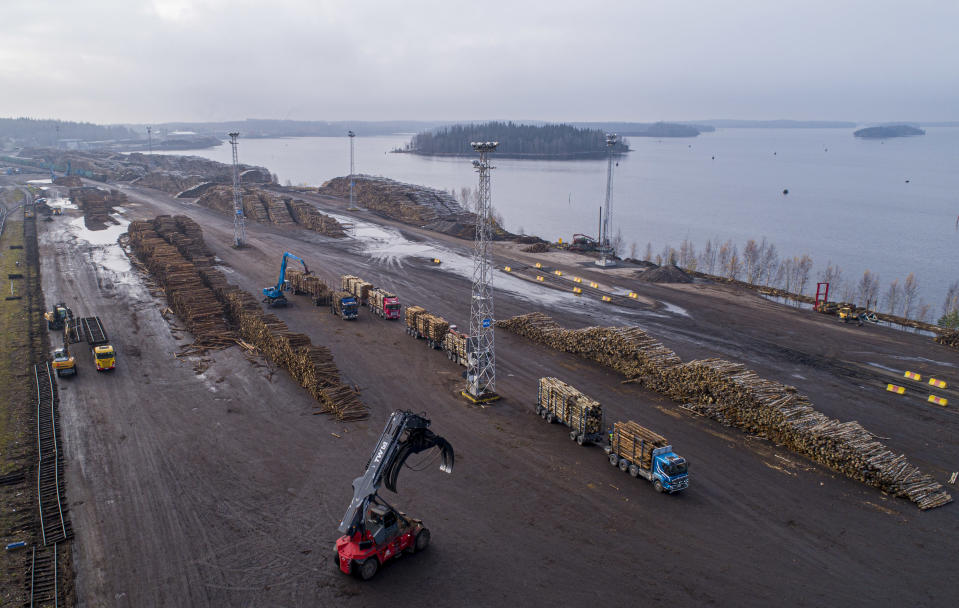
{"left": 128, "top": 216, "right": 368, "bottom": 420}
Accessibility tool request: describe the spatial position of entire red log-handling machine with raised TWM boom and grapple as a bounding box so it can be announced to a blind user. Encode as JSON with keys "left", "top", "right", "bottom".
{"left": 335, "top": 410, "right": 453, "bottom": 580}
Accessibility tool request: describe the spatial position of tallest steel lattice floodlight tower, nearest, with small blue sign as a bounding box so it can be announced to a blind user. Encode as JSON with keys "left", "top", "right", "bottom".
{"left": 462, "top": 141, "right": 499, "bottom": 403}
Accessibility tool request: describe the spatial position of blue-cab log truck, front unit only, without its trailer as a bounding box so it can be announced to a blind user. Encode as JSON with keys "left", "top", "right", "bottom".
{"left": 605, "top": 420, "right": 689, "bottom": 494}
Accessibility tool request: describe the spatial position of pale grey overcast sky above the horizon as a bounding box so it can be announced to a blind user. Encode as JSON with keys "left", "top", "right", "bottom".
{"left": 0, "top": 0, "right": 959, "bottom": 123}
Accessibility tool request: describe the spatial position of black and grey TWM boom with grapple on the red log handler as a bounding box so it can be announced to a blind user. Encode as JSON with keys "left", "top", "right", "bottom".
{"left": 339, "top": 410, "right": 453, "bottom": 535}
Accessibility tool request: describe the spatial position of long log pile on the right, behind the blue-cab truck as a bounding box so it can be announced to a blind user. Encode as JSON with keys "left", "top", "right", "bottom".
{"left": 497, "top": 313, "right": 952, "bottom": 509}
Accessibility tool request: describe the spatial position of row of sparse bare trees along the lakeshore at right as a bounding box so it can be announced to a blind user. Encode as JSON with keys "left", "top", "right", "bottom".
{"left": 632, "top": 237, "right": 959, "bottom": 328}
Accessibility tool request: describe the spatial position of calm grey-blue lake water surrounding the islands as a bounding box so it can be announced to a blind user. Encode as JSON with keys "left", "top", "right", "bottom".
{"left": 172, "top": 128, "right": 959, "bottom": 318}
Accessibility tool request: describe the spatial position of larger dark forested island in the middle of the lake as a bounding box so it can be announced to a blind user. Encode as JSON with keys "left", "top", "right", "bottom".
{"left": 394, "top": 122, "right": 629, "bottom": 160}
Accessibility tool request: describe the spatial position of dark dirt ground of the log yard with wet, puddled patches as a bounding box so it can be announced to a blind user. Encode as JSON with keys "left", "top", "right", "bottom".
{"left": 41, "top": 186, "right": 959, "bottom": 607}
